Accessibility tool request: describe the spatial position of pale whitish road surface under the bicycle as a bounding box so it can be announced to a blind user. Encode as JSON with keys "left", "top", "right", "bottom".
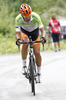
{"left": 0, "top": 50, "right": 66, "bottom": 100}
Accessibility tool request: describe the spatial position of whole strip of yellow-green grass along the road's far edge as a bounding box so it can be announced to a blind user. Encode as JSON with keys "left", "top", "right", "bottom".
{"left": 0, "top": 36, "right": 66, "bottom": 55}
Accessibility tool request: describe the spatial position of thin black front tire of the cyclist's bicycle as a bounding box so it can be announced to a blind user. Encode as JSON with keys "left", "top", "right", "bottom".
{"left": 30, "top": 57, "right": 35, "bottom": 95}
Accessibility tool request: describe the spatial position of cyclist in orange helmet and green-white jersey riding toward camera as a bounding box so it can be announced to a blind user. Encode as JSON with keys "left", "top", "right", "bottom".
{"left": 15, "top": 4, "right": 46, "bottom": 75}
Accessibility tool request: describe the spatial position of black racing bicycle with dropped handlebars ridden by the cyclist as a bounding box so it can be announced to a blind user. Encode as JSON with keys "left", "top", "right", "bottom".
{"left": 19, "top": 37, "right": 41, "bottom": 95}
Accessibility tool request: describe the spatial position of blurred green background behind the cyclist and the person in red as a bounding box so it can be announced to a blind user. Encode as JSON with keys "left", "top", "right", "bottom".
{"left": 0, "top": 0, "right": 66, "bottom": 55}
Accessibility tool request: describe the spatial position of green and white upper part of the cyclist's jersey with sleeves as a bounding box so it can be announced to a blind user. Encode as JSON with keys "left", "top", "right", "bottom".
{"left": 15, "top": 12, "right": 43, "bottom": 32}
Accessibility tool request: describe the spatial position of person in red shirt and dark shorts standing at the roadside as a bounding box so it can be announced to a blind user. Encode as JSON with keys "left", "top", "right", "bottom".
{"left": 48, "top": 14, "right": 63, "bottom": 52}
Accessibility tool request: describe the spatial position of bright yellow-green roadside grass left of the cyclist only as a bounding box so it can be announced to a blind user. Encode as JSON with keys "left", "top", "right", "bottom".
{"left": 0, "top": 37, "right": 18, "bottom": 55}
